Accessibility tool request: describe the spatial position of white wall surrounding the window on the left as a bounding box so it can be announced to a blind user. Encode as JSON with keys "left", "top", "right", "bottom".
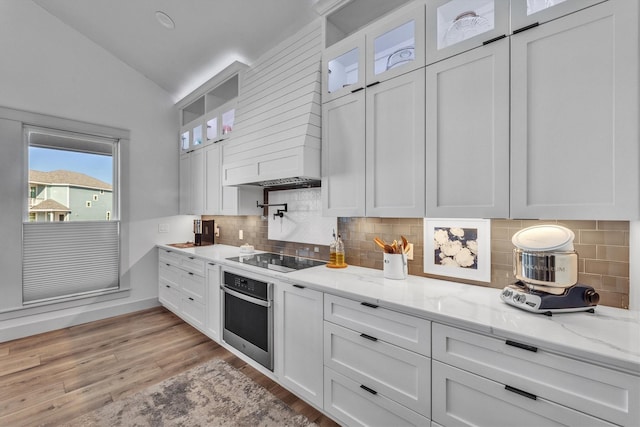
{"left": 0, "top": 0, "right": 192, "bottom": 342}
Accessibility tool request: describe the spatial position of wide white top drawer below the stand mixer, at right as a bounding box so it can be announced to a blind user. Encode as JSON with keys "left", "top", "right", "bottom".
{"left": 432, "top": 323, "right": 640, "bottom": 425}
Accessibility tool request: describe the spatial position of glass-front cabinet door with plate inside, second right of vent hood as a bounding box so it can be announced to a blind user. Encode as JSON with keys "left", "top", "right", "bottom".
{"left": 366, "top": 4, "right": 425, "bottom": 85}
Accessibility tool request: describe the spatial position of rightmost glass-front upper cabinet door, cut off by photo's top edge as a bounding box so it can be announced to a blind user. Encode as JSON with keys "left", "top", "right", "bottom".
{"left": 511, "top": 0, "right": 608, "bottom": 33}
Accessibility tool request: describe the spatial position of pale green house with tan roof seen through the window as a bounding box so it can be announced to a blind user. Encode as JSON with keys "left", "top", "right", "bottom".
{"left": 29, "top": 170, "right": 113, "bottom": 222}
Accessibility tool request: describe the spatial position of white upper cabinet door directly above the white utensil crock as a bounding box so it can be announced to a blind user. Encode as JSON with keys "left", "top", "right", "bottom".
{"left": 365, "top": 68, "right": 425, "bottom": 218}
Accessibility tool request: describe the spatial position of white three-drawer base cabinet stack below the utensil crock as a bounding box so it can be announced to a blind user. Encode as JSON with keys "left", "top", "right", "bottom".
{"left": 324, "top": 294, "right": 431, "bottom": 425}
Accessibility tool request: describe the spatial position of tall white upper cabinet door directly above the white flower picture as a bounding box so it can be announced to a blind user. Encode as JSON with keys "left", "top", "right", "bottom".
{"left": 426, "top": 38, "right": 509, "bottom": 218}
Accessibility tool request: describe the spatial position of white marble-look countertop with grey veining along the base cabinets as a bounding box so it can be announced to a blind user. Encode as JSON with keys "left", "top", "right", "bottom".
{"left": 158, "top": 244, "right": 640, "bottom": 376}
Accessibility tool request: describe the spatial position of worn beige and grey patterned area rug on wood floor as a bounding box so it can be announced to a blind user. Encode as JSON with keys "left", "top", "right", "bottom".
{"left": 66, "top": 360, "right": 315, "bottom": 427}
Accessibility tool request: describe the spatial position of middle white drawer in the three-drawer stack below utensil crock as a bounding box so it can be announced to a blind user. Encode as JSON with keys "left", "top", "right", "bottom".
{"left": 324, "top": 322, "right": 431, "bottom": 417}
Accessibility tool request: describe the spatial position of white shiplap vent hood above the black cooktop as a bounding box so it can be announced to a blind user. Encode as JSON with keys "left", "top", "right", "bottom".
{"left": 222, "top": 20, "right": 322, "bottom": 187}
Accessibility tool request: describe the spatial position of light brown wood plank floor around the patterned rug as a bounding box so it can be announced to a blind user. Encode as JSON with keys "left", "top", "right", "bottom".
{"left": 0, "top": 307, "right": 337, "bottom": 427}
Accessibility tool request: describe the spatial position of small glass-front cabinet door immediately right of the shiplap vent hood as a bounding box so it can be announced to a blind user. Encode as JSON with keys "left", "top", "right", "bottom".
{"left": 322, "top": 35, "right": 364, "bottom": 102}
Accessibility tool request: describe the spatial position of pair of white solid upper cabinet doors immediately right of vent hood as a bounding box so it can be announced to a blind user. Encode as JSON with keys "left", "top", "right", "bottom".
{"left": 322, "top": 69, "right": 425, "bottom": 221}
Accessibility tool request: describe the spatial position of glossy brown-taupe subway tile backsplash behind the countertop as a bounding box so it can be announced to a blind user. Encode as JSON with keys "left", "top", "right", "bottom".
{"left": 203, "top": 216, "right": 629, "bottom": 308}
